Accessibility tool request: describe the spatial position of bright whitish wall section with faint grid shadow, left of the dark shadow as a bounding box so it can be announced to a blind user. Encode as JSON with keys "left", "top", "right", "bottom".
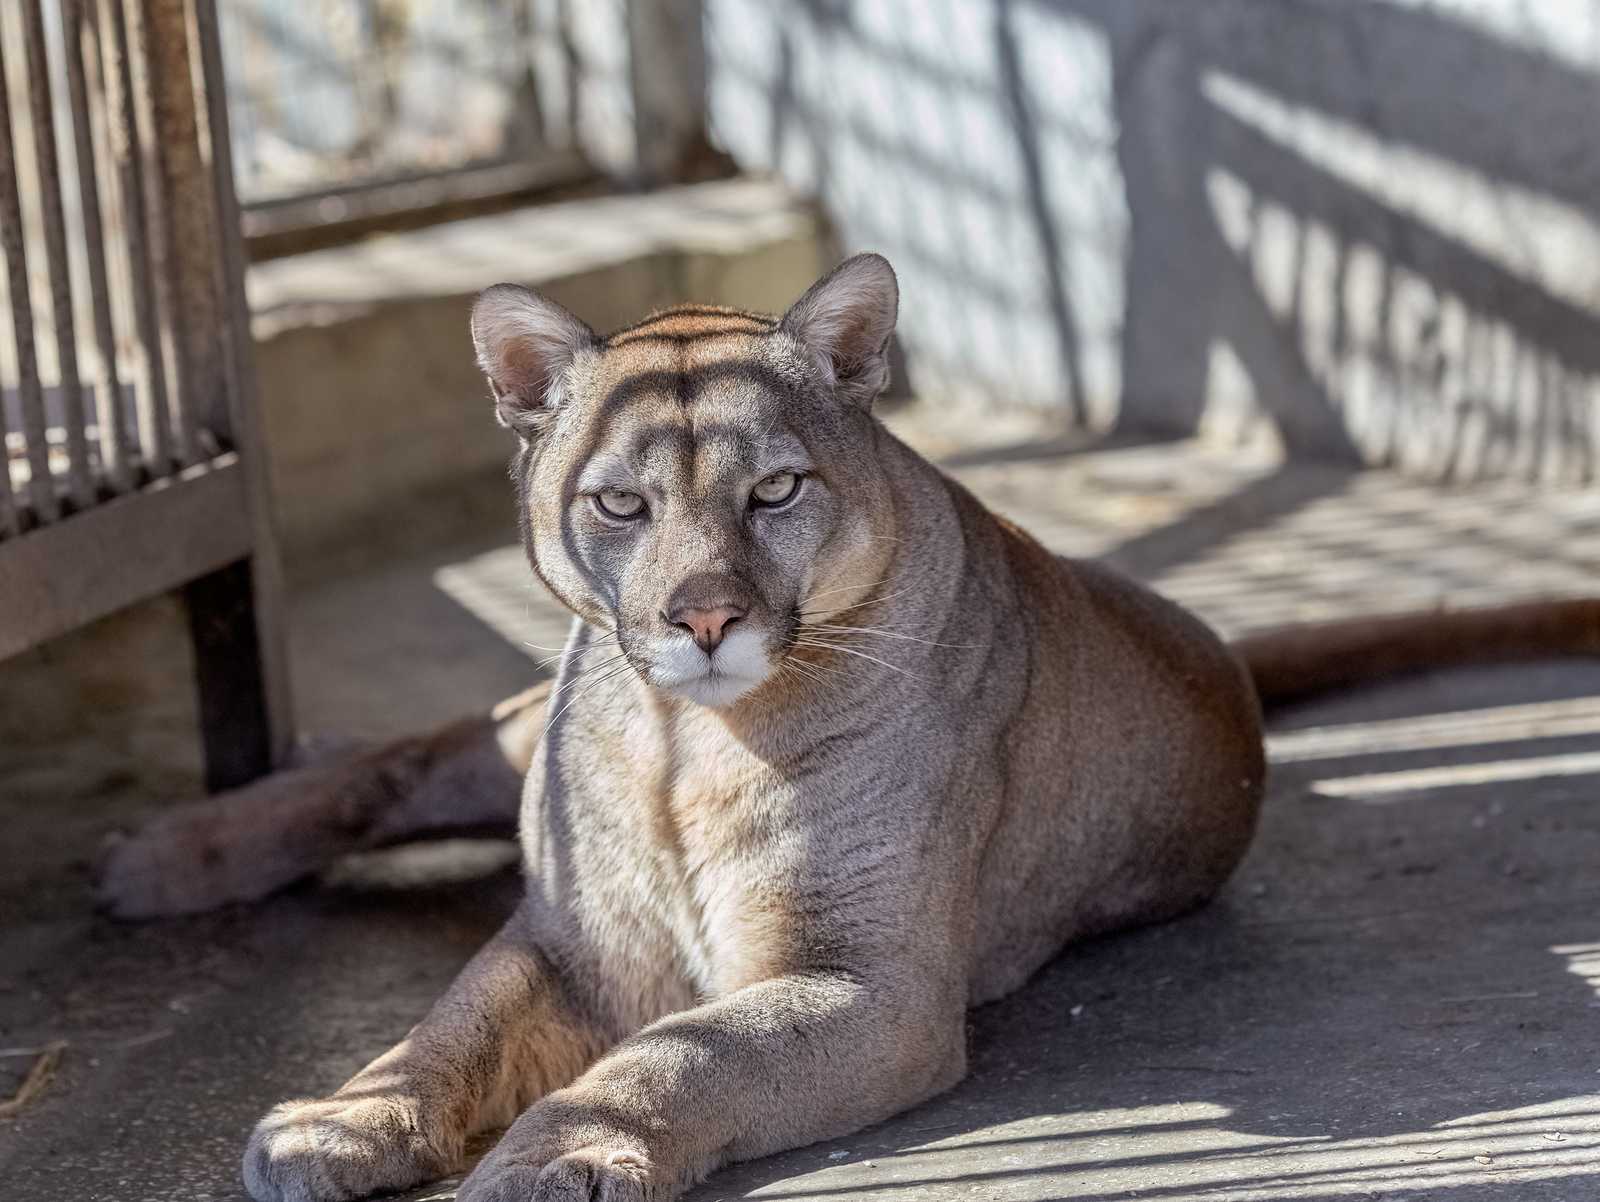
{"left": 706, "top": 0, "right": 1126, "bottom": 424}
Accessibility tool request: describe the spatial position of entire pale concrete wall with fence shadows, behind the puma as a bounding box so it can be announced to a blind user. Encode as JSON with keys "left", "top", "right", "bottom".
{"left": 707, "top": 0, "right": 1600, "bottom": 480}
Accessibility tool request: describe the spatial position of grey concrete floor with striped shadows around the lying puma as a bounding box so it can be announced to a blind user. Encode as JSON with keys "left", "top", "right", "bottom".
{"left": 0, "top": 419, "right": 1600, "bottom": 1202}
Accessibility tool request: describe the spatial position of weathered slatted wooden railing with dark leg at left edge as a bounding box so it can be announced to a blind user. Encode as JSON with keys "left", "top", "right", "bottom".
{"left": 0, "top": 0, "right": 290, "bottom": 786}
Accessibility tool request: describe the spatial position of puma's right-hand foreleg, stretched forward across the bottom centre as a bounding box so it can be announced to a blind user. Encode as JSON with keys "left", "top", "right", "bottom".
{"left": 458, "top": 972, "right": 966, "bottom": 1202}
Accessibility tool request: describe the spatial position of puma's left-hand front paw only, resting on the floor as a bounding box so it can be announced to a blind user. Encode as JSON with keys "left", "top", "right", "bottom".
{"left": 245, "top": 1098, "right": 454, "bottom": 1202}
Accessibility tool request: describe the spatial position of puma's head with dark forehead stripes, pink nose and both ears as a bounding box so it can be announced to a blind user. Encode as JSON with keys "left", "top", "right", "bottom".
{"left": 472, "top": 254, "right": 898, "bottom": 706}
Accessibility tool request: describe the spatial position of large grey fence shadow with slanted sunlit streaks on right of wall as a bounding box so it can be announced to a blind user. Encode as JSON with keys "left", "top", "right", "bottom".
{"left": 1062, "top": 0, "right": 1600, "bottom": 483}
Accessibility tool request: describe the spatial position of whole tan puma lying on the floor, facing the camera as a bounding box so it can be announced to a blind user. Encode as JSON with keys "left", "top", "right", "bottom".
{"left": 101, "top": 254, "right": 1597, "bottom": 1202}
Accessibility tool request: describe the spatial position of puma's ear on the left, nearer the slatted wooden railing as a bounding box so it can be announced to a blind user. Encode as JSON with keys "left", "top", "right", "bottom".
{"left": 472, "top": 283, "right": 600, "bottom": 439}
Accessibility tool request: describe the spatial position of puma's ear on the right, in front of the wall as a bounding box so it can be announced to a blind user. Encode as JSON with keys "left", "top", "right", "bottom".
{"left": 778, "top": 254, "right": 899, "bottom": 408}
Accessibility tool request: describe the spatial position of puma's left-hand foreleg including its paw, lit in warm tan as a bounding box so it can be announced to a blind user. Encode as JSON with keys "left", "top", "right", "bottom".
{"left": 243, "top": 916, "right": 605, "bottom": 1202}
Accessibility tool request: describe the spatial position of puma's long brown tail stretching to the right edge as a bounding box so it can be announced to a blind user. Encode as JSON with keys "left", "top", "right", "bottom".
{"left": 1232, "top": 599, "right": 1600, "bottom": 709}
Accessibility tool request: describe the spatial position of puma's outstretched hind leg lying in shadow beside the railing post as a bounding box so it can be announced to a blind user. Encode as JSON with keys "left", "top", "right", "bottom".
{"left": 94, "top": 685, "right": 549, "bottom": 919}
